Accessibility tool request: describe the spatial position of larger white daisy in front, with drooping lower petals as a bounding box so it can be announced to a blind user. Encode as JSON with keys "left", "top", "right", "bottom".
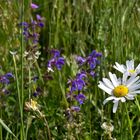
{"left": 98, "top": 72, "right": 140, "bottom": 113}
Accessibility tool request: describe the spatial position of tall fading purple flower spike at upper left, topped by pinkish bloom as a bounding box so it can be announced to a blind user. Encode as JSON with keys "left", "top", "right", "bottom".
{"left": 20, "top": 3, "right": 44, "bottom": 62}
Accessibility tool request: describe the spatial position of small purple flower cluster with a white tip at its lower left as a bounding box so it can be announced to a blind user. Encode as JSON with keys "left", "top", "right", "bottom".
{"left": 47, "top": 49, "right": 65, "bottom": 71}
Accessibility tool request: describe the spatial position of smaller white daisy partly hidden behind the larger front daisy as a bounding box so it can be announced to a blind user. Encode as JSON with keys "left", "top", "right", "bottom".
{"left": 113, "top": 60, "right": 140, "bottom": 76}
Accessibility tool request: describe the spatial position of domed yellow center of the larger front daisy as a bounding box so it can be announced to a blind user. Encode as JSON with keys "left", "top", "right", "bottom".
{"left": 113, "top": 85, "right": 128, "bottom": 97}
